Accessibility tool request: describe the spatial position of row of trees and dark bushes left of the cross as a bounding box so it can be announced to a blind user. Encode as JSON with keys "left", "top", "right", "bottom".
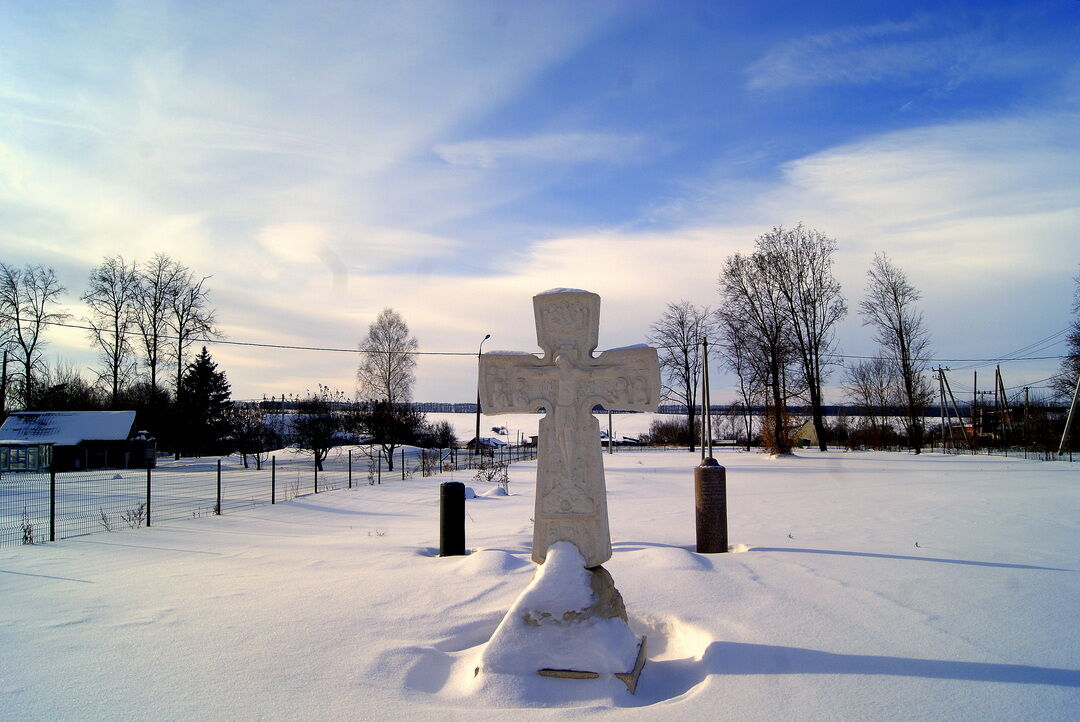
{"left": 0, "top": 262, "right": 457, "bottom": 471}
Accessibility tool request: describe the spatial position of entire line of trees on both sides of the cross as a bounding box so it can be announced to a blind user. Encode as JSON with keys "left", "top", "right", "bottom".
{"left": 0, "top": 237, "right": 1080, "bottom": 455}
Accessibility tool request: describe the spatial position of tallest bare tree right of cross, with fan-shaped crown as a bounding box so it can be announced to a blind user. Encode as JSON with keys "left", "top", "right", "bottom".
{"left": 757, "top": 223, "right": 848, "bottom": 451}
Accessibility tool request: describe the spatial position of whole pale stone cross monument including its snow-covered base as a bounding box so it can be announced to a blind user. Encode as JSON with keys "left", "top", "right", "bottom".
{"left": 477, "top": 288, "right": 660, "bottom": 692}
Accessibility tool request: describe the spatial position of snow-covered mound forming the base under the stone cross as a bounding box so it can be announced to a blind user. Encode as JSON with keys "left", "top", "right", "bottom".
{"left": 481, "top": 542, "right": 638, "bottom": 675}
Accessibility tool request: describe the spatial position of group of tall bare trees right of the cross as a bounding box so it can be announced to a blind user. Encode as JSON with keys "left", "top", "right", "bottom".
{"left": 649, "top": 223, "right": 1080, "bottom": 453}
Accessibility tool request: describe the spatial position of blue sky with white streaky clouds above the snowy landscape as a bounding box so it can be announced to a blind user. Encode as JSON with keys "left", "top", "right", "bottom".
{"left": 0, "top": 0, "right": 1080, "bottom": 400}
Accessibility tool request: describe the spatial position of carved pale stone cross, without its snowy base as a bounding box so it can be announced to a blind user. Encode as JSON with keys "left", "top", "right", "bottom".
{"left": 480, "top": 288, "right": 660, "bottom": 568}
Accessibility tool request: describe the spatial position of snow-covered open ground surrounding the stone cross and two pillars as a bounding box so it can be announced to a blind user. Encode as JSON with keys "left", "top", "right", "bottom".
{"left": 0, "top": 446, "right": 1080, "bottom": 720}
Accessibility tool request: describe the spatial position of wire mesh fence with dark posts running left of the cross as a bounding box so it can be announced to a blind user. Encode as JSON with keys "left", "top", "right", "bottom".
{"left": 0, "top": 447, "right": 536, "bottom": 546}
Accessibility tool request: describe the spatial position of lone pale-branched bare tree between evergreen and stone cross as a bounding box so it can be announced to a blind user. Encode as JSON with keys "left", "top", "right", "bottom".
{"left": 356, "top": 309, "right": 417, "bottom": 405}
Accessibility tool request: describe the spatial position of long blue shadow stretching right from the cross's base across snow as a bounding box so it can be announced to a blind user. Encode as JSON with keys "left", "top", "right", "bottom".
{"left": 617, "top": 642, "right": 1080, "bottom": 707}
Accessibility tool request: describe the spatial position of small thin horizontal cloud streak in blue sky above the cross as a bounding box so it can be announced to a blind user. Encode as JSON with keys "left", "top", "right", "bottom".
{"left": 433, "top": 133, "right": 647, "bottom": 168}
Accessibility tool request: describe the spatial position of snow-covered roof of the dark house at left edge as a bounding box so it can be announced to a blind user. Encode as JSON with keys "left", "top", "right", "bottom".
{"left": 0, "top": 411, "right": 135, "bottom": 446}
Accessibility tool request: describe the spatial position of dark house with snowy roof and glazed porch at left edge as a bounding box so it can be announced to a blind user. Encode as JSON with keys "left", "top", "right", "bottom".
{"left": 0, "top": 411, "right": 157, "bottom": 472}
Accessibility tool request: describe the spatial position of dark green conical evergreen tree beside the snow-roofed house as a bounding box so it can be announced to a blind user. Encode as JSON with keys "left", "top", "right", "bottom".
{"left": 176, "top": 346, "right": 231, "bottom": 455}
